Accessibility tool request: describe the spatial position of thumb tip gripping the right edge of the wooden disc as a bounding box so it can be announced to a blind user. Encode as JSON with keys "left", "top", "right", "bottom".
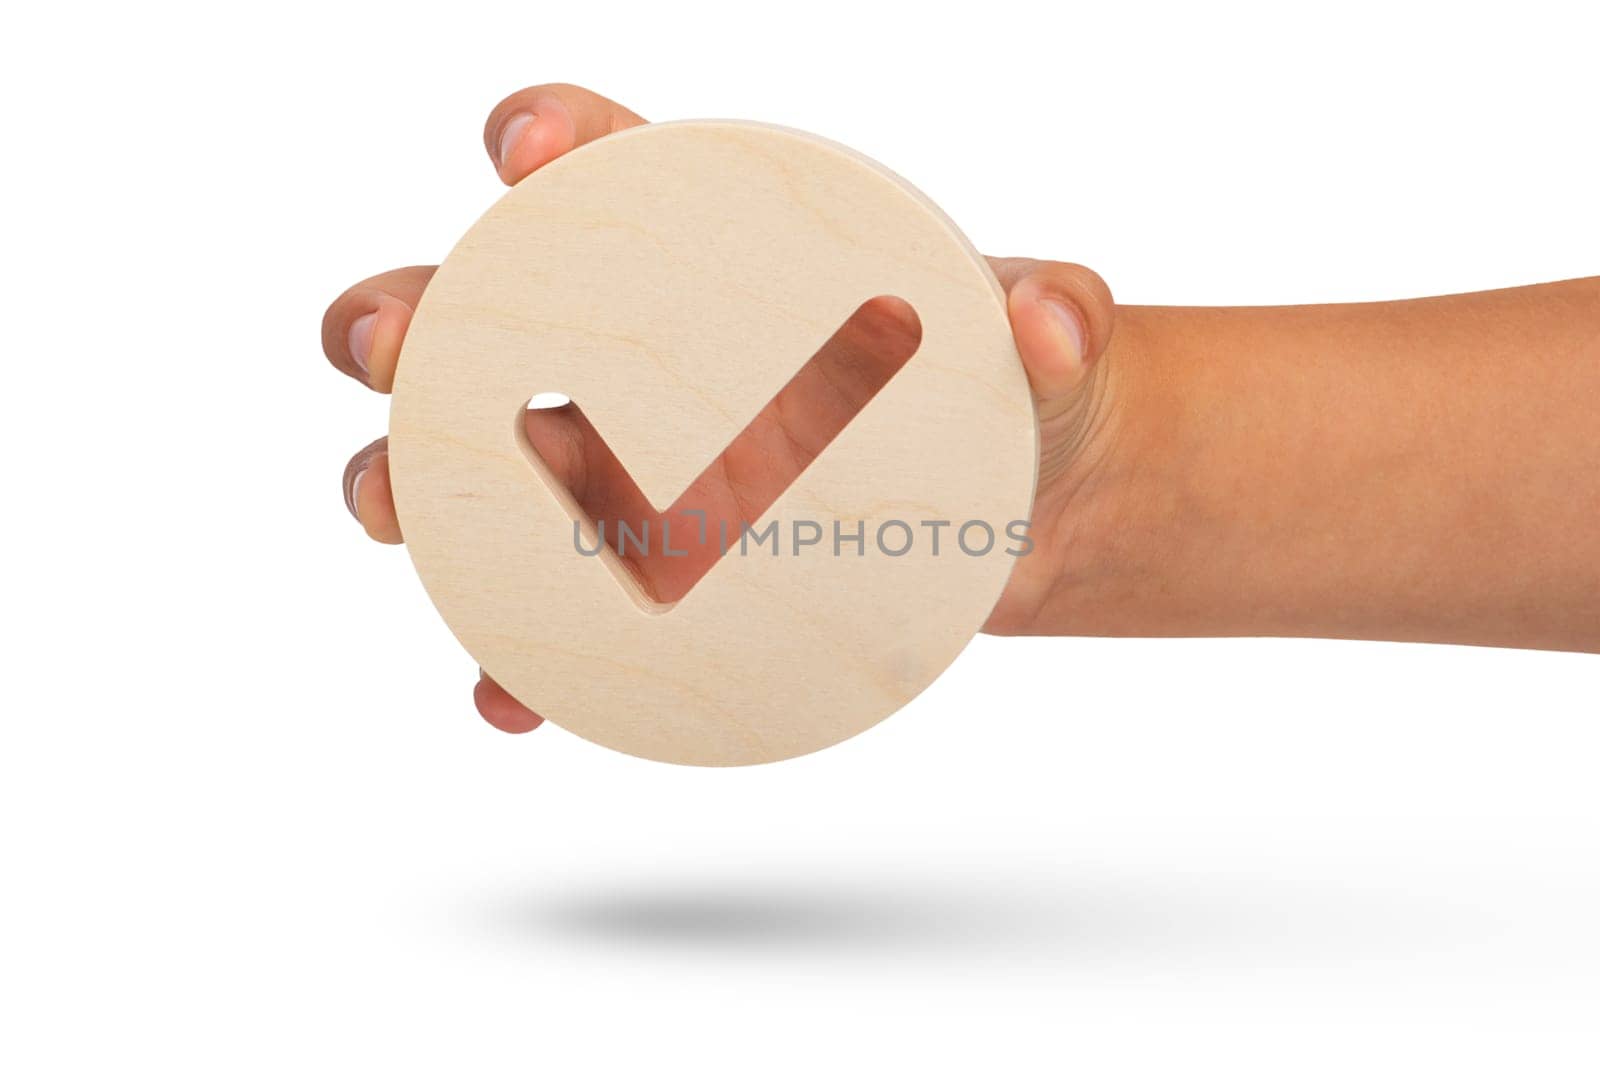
{"left": 990, "top": 259, "right": 1115, "bottom": 405}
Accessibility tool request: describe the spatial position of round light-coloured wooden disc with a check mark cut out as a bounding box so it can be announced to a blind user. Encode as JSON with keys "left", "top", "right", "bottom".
{"left": 389, "top": 122, "right": 1037, "bottom": 765}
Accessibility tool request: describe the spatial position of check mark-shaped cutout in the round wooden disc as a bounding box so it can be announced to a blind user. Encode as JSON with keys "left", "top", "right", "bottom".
{"left": 520, "top": 296, "right": 922, "bottom": 613}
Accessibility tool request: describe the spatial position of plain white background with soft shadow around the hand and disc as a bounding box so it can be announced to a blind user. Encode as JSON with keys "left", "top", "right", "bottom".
{"left": 0, "top": 0, "right": 1600, "bottom": 1064}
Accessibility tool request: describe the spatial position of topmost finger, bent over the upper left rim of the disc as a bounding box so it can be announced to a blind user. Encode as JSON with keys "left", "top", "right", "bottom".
{"left": 483, "top": 85, "right": 645, "bottom": 186}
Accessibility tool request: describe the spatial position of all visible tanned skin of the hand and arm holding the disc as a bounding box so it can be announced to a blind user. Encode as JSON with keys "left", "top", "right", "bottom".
{"left": 322, "top": 85, "right": 1600, "bottom": 733}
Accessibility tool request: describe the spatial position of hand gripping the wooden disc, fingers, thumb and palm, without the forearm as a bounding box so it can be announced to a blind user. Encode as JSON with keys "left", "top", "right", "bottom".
{"left": 322, "top": 85, "right": 1115, "bottom": 733}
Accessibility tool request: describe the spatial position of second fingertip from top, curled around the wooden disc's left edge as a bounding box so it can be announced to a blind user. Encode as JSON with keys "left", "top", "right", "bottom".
{"left": 322, "top": 266, "right": 437, "bottom": 392}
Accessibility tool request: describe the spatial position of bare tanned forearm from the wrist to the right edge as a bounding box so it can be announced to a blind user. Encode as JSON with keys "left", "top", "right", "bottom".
{"left": 1034, "top": 279, "right": 1600, "bottom": 650}
